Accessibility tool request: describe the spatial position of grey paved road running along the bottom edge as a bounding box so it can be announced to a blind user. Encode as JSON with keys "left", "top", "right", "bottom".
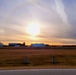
{"left": 0, "top": 69, "right": 76, "bottom": 75}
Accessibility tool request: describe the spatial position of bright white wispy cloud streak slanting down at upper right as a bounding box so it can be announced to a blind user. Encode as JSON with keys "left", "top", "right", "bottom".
{"left": 55, "top": 0, "right": 69, "bottom": 25}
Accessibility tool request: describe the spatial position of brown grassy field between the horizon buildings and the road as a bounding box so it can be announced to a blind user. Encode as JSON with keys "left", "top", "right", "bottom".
{"left": 0, "top": 48, "right": 76, "bottom": 68}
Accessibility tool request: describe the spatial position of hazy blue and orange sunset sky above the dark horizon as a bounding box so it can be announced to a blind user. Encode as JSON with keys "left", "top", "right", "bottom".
{"left": 0, "top": 0, "right": 76, "bottom": 45}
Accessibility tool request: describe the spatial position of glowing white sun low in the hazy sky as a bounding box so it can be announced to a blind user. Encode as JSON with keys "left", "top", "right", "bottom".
{"left": 27, "top": 23, "right": 40, "bottom": 36}
